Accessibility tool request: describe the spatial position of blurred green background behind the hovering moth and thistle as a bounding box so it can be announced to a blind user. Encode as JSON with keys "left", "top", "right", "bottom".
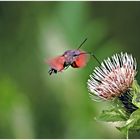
{"left": 0, "top": 1, "right": 140, "bottom": 139}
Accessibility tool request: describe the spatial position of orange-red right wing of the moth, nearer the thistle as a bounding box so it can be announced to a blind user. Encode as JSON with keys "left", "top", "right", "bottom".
{"left": 71, "top": 51, "right": 89, "bottom": 68}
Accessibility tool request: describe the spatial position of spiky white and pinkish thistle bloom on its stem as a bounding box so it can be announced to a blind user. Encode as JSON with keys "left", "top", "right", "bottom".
{"left": 87, "top": 53, "right": 136, "bottom": 99}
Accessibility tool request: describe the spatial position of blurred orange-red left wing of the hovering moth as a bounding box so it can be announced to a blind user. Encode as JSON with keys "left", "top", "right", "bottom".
{"left": 47, "top": 56, "right": 65, "bottom": 71}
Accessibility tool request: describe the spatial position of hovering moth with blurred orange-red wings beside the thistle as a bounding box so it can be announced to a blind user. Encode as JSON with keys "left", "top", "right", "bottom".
{"left": 47, "top": 38, "right": 99, "bottom": 75}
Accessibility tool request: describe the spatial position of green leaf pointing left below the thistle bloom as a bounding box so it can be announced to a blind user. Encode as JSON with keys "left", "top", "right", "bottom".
{"left": 97, "top": 108, "right": 126, "bottom": 122}
